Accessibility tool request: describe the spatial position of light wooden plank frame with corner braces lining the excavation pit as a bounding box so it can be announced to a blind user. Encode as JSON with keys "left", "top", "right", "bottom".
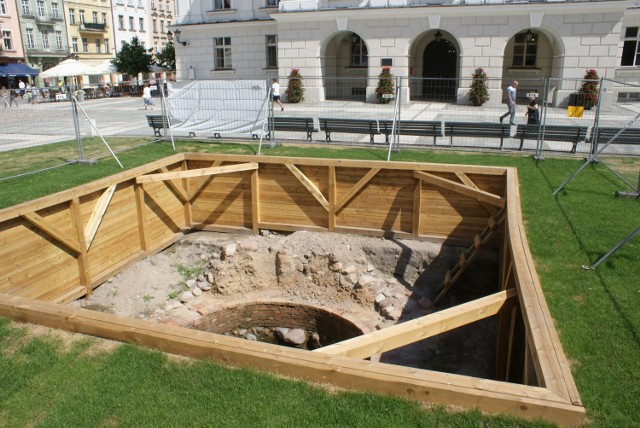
{"left": 0, "top": 154, "right": 585, "bottom": 425}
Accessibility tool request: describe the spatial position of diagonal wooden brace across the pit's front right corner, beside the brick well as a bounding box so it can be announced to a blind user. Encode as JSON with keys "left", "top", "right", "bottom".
{"left": 314, "top": 289, "right": 517, "bottom": 358}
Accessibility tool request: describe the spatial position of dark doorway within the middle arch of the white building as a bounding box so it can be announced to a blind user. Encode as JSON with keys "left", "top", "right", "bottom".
{"left": 422, "top": 40, "right": 458, "bottom": 102}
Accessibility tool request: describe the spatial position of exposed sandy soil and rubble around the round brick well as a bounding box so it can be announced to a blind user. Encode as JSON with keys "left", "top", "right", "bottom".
{"left": 72, "top": 231, "right": 497, "bottom": 378}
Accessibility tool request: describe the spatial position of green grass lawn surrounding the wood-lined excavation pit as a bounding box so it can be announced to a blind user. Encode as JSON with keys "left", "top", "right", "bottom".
{"left": 0, "top": 142, "right": 640, "bottom": 427}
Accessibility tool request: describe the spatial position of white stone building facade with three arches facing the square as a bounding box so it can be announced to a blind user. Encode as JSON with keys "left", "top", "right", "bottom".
{"left": 172, "top": 0, "right": 640, "bottom": 103}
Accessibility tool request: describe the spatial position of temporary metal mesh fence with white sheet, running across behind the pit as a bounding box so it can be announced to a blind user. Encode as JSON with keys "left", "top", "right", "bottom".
{"left": 0, "top": 76, "right": 640, "bottom": 192}
